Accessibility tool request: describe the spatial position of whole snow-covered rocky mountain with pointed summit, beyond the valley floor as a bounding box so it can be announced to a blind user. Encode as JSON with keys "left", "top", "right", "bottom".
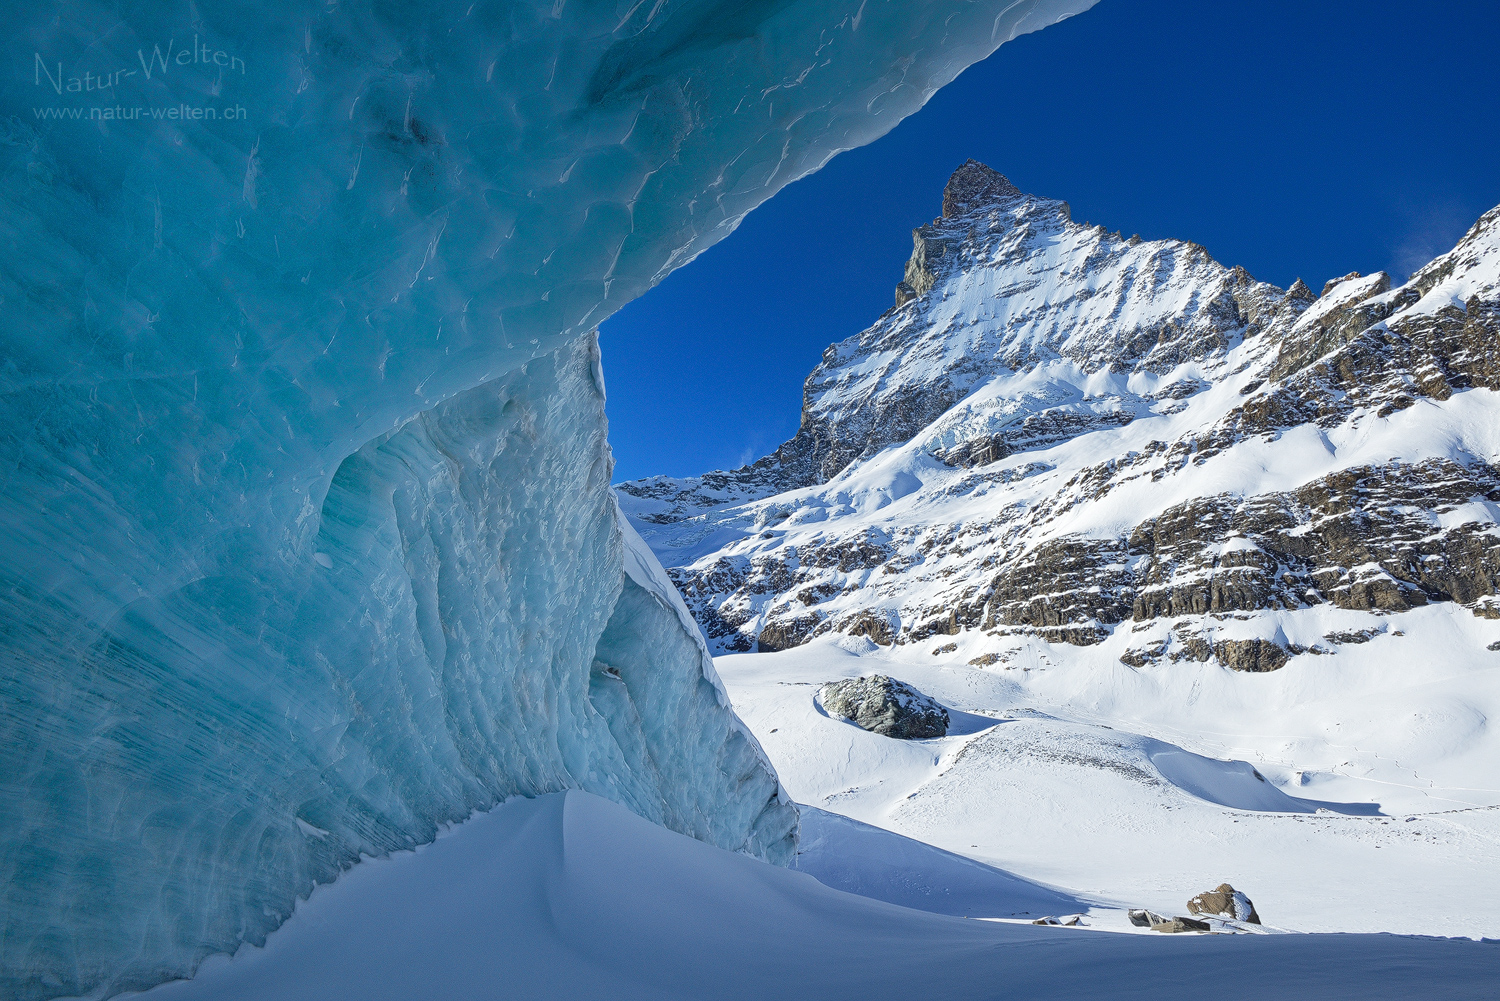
{"left": 617, "top": 161, "right": 1500, "bottom": 671}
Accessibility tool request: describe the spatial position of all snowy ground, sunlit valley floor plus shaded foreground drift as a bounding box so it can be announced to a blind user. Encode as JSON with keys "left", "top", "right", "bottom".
{"left": 132, "top": 621, "right": 1500, "bottom": 1001}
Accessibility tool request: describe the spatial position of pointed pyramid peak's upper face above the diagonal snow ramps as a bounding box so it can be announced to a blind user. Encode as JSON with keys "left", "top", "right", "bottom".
{"left": 623, "top": 161, "right": 1310, "bottom": 531}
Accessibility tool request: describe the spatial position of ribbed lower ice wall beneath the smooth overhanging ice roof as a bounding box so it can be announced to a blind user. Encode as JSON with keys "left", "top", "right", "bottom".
{"left": 6, "top": 338, "right": 795, "bottom": 996}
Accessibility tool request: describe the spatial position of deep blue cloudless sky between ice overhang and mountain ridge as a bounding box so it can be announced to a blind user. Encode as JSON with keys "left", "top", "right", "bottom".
{"left": 602, "top": 0, "right": 1500, "bottom": 480}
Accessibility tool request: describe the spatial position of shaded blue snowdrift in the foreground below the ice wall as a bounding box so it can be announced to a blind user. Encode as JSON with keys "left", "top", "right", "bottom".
{"left": 132, "top": 792, "right": 1500, "bottom": 1001}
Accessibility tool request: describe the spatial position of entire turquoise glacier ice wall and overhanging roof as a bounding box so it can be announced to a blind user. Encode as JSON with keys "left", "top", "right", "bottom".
{"left": 0, "top": 0, "right": 1091, "bottom": 998}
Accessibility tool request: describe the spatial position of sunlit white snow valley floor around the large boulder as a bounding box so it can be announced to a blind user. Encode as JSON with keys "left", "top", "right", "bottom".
{"left": 717, "top": 621, "right": 1500, "bottom": 938}
